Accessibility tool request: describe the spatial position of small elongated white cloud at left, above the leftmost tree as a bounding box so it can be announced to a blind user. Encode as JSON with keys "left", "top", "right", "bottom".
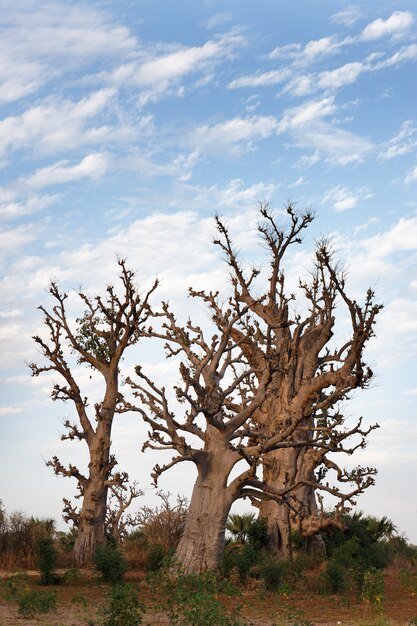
{"left": 26, "top": 153, "right": 108, "bottom": 189}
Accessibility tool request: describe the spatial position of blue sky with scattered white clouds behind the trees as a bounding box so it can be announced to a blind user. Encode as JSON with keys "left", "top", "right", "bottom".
{"left": 0, "top": 0, "right": 417, "bottom": 542}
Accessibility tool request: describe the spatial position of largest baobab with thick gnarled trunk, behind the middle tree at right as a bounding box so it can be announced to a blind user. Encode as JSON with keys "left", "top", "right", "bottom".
{"left": 215, "top": 204, "right": 381, "bottom": 557}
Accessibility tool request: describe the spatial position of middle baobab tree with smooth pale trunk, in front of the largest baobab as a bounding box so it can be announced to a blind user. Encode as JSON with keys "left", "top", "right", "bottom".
{"left": 126, "top": 222, "right": 374, "bottom": 574}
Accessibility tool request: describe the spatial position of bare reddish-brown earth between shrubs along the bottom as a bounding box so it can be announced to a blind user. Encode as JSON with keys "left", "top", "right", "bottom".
{"left": 0, "top": 569, "right": 417, "bottom": 626}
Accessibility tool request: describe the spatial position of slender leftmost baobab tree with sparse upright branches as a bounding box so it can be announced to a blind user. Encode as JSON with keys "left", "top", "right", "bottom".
{"left": 30, "top": 260, "right": 157, "bottom": 564}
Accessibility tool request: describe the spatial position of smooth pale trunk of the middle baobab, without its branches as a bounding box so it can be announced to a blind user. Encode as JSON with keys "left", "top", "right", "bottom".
{"left": 175, "top": 451, "right": 236, "bottom": 574}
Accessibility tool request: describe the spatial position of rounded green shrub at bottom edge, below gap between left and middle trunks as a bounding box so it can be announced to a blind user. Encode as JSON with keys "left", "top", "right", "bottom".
{"left": 100, "top": 584, "right": 145, "bottom": 626}
